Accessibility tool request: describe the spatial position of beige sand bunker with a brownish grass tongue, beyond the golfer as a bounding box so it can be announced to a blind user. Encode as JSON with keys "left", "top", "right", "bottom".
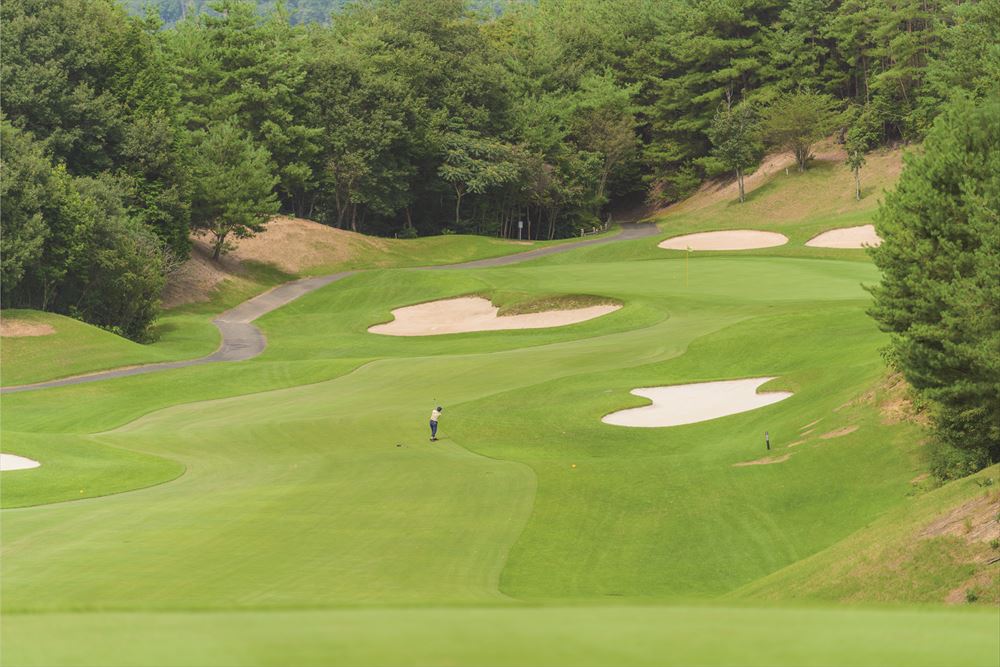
{"left": 368, "top": 296, "right": 621, "bottom": 336}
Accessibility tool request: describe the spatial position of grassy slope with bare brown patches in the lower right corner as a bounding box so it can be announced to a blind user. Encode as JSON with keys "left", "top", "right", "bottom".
{"left": 732, "top": 466, "right": 1000, "bottom": 605}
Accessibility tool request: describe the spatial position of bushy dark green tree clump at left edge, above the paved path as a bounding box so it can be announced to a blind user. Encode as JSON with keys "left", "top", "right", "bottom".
{"left": 2, "top": 121, "right": 167, "bottom": 340}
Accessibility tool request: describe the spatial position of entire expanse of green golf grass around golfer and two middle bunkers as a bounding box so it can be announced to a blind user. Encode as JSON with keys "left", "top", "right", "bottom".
{"left": 2, "top": 234, "right": 1000, "bottom": 666}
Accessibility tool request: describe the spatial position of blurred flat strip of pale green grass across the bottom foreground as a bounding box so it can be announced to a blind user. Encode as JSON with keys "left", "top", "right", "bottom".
{"left": 3, "top": 606, "right": 1000, "bottom": 667}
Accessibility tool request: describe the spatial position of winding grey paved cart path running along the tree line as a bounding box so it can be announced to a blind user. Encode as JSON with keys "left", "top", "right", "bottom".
{"left": 0, "top": 223, "right": 659, "bottom": 394}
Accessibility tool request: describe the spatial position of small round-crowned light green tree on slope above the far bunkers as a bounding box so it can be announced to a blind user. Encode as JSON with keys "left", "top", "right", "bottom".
{"left": 763, "top": 90, "right": 840, "bottom": 171}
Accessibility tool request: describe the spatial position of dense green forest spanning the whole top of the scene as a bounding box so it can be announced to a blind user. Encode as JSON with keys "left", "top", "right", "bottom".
{"left": 0, "top": 0, "right": 1000, "bottom": 338}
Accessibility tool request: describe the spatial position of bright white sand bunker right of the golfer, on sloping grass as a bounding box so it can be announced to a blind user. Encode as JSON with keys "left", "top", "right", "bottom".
{"left": 601, "top": 378, "right": 791, "bottom": 428}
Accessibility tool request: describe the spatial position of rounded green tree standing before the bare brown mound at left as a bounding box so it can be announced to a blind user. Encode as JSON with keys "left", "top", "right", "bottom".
{"left": 191, "top": 123, "right": 278, "bottom": 259}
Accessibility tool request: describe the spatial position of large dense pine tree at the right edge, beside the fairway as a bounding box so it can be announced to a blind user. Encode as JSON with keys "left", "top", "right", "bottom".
{"left": 872, "top": 96, "right": 1000, "bottom": 476}
